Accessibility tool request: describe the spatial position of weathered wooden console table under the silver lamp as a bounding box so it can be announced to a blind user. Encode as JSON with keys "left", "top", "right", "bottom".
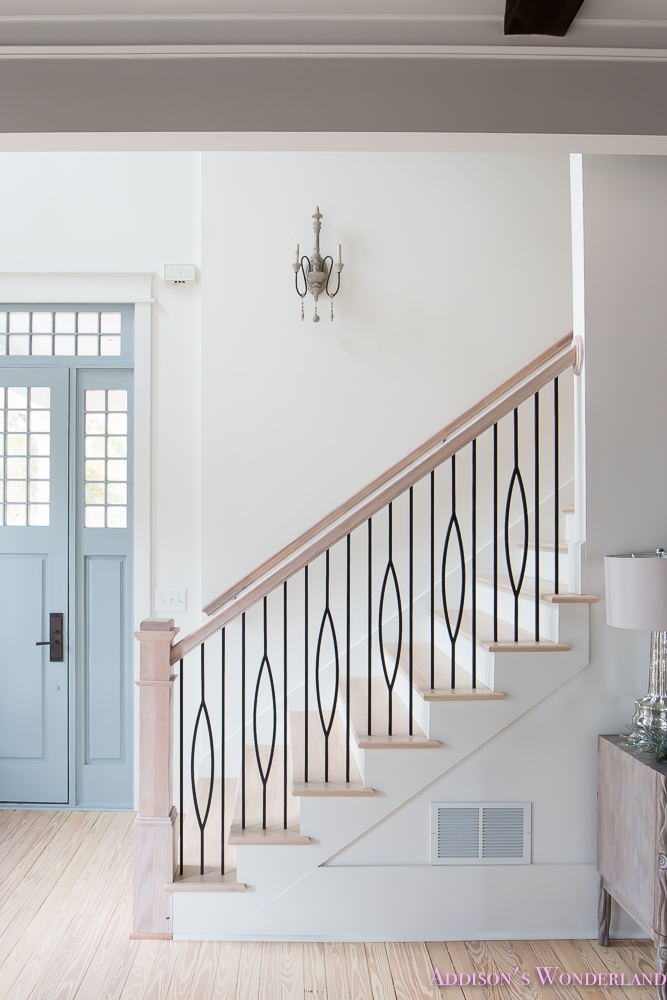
{"left": 597, "top": 736, "right": 667, "bottom": 1000}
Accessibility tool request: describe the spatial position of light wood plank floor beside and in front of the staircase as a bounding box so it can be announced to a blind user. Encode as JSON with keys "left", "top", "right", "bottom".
{"left": 0, "top": 810, "right": 655, "bottom": 1000}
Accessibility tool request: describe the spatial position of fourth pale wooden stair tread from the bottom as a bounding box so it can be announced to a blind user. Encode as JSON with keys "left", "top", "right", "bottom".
{"left": 343, "top": 677, "right": 440, "bottom": 750}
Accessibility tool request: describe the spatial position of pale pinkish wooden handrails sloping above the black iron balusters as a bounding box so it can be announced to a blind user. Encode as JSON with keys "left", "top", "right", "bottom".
{"left": 171, "top": 333, "right": 581, "bottom": 663}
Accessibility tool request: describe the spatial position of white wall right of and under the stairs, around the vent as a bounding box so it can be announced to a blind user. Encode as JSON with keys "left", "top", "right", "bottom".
{"left": 324, "top": 148, "right": 667, "bottom": 933}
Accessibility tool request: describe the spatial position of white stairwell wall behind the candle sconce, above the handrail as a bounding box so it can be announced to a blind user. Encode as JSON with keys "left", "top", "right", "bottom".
{"left": 202, "top": 153, "right": 572, "bottom": 600}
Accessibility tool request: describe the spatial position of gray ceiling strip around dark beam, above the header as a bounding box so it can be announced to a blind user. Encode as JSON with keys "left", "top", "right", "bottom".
{"left": 0, "top": 0, "right": 667, "bottom": 49}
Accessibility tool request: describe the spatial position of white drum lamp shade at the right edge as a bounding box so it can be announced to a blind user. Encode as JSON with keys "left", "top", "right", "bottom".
{"left": 604, "top": 550, "right": 667, "bottom": 632}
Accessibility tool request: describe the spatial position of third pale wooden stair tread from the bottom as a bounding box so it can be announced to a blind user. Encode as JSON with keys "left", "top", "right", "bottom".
{"left": 290, "top": 712, "right": 375, "bottom": 797}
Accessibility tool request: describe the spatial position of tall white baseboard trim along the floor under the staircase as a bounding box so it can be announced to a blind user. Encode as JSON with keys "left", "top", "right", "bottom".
{"left": 172, "top": 864, "right": 646, "bottom": 940}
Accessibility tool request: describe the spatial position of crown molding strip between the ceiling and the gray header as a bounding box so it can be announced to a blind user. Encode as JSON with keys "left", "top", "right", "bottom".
{"left": 0, "top": 11, "right": 667, "bottom": 50}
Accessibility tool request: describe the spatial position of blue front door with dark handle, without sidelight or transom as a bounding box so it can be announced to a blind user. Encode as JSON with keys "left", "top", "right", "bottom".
{"left": 0, "top": 367, "right": 70, "bottom": 804}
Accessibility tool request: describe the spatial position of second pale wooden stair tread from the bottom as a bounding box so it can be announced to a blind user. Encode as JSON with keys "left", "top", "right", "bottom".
{"left": 229, "top": 744, "right": 310, "bottom": 846}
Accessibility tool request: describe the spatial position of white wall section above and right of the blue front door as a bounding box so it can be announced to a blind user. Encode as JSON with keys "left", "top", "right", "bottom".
{"left": 0, "top": 153, "right": 201, "bottom": 631}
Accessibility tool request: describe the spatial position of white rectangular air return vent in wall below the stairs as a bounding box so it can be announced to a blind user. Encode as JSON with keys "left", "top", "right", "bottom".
{"left": 431, "top": 802, "right": 530, "bottom": 865}
